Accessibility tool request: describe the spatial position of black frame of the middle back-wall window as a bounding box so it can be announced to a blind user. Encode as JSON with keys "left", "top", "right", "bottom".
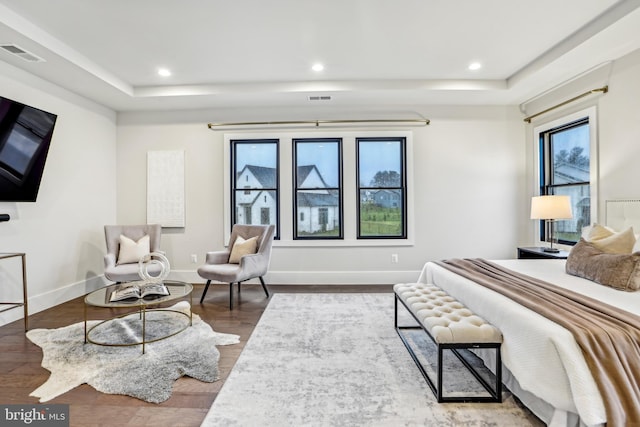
{"left": 291, "top": 137, "right": 344, "bottom": 240}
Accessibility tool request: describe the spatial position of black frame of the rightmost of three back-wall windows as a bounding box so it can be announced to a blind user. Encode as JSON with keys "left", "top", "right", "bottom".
{"left": 355, "top": 136, "right": 408, "bottom": 240}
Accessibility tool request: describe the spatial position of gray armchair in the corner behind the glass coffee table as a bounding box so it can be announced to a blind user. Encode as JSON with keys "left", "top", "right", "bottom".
{"left": 104, "top": 224, "right": 162, "bottom": 283}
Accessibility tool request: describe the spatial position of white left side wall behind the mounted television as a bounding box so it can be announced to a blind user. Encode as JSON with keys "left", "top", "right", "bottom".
{"left": 0, "top": 61, "right": 116, "bottom": 324}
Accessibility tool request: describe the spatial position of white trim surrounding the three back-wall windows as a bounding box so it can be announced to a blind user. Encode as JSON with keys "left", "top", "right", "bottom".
{"left": 223, "top": 131, "right": 415, "bottom": 248}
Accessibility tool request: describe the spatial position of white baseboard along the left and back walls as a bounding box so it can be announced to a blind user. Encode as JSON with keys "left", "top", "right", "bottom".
{"left": 0, "top": 270, "right": 420, "bottom": 326}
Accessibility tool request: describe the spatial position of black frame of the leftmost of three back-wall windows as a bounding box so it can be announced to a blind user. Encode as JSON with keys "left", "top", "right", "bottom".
{"left": 229, "top": 138, "right": 280, "bottom": 240}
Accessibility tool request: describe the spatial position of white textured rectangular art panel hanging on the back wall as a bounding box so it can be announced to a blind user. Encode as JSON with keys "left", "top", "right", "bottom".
{"left": 147, "top": 151, "right": 185, "bottom": 227}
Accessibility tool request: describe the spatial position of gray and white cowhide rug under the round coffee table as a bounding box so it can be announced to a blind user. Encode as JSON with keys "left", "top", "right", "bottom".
{"left": 27, "top": 302, "right": 239, "bottom": 403}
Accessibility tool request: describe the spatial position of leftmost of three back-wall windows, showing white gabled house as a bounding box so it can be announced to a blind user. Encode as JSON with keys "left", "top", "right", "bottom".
{"left": 231, "top": 139, "right": 280, "bottom": 241}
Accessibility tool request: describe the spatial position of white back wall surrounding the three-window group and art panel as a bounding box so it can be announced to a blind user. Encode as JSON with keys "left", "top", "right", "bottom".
{"left": 117, "top": 107, "right": 529, "bottom": 284}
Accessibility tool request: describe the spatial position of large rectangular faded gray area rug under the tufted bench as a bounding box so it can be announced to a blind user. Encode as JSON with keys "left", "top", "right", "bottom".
{"left": 202, "top": 294, "right": 543, "bottom": 427}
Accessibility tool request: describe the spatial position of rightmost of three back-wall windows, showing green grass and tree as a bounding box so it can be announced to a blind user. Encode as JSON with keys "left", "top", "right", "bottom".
{"left": 356, "top": 138, "right": 407, "bottom": 239}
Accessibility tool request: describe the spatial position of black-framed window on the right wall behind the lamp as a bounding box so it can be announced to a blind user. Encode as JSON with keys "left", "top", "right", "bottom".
{"left": 539, "top": 117, "right": 592, "bottom": 244}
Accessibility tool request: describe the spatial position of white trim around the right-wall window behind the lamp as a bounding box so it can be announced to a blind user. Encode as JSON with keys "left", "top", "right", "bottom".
{"left": 533, "top": 106, "right": 599, "bottom": 250}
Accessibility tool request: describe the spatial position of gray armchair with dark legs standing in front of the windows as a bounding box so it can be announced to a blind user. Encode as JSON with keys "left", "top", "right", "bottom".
{"left": 198, "top": 224, "right": 275, "bottom": 310}
